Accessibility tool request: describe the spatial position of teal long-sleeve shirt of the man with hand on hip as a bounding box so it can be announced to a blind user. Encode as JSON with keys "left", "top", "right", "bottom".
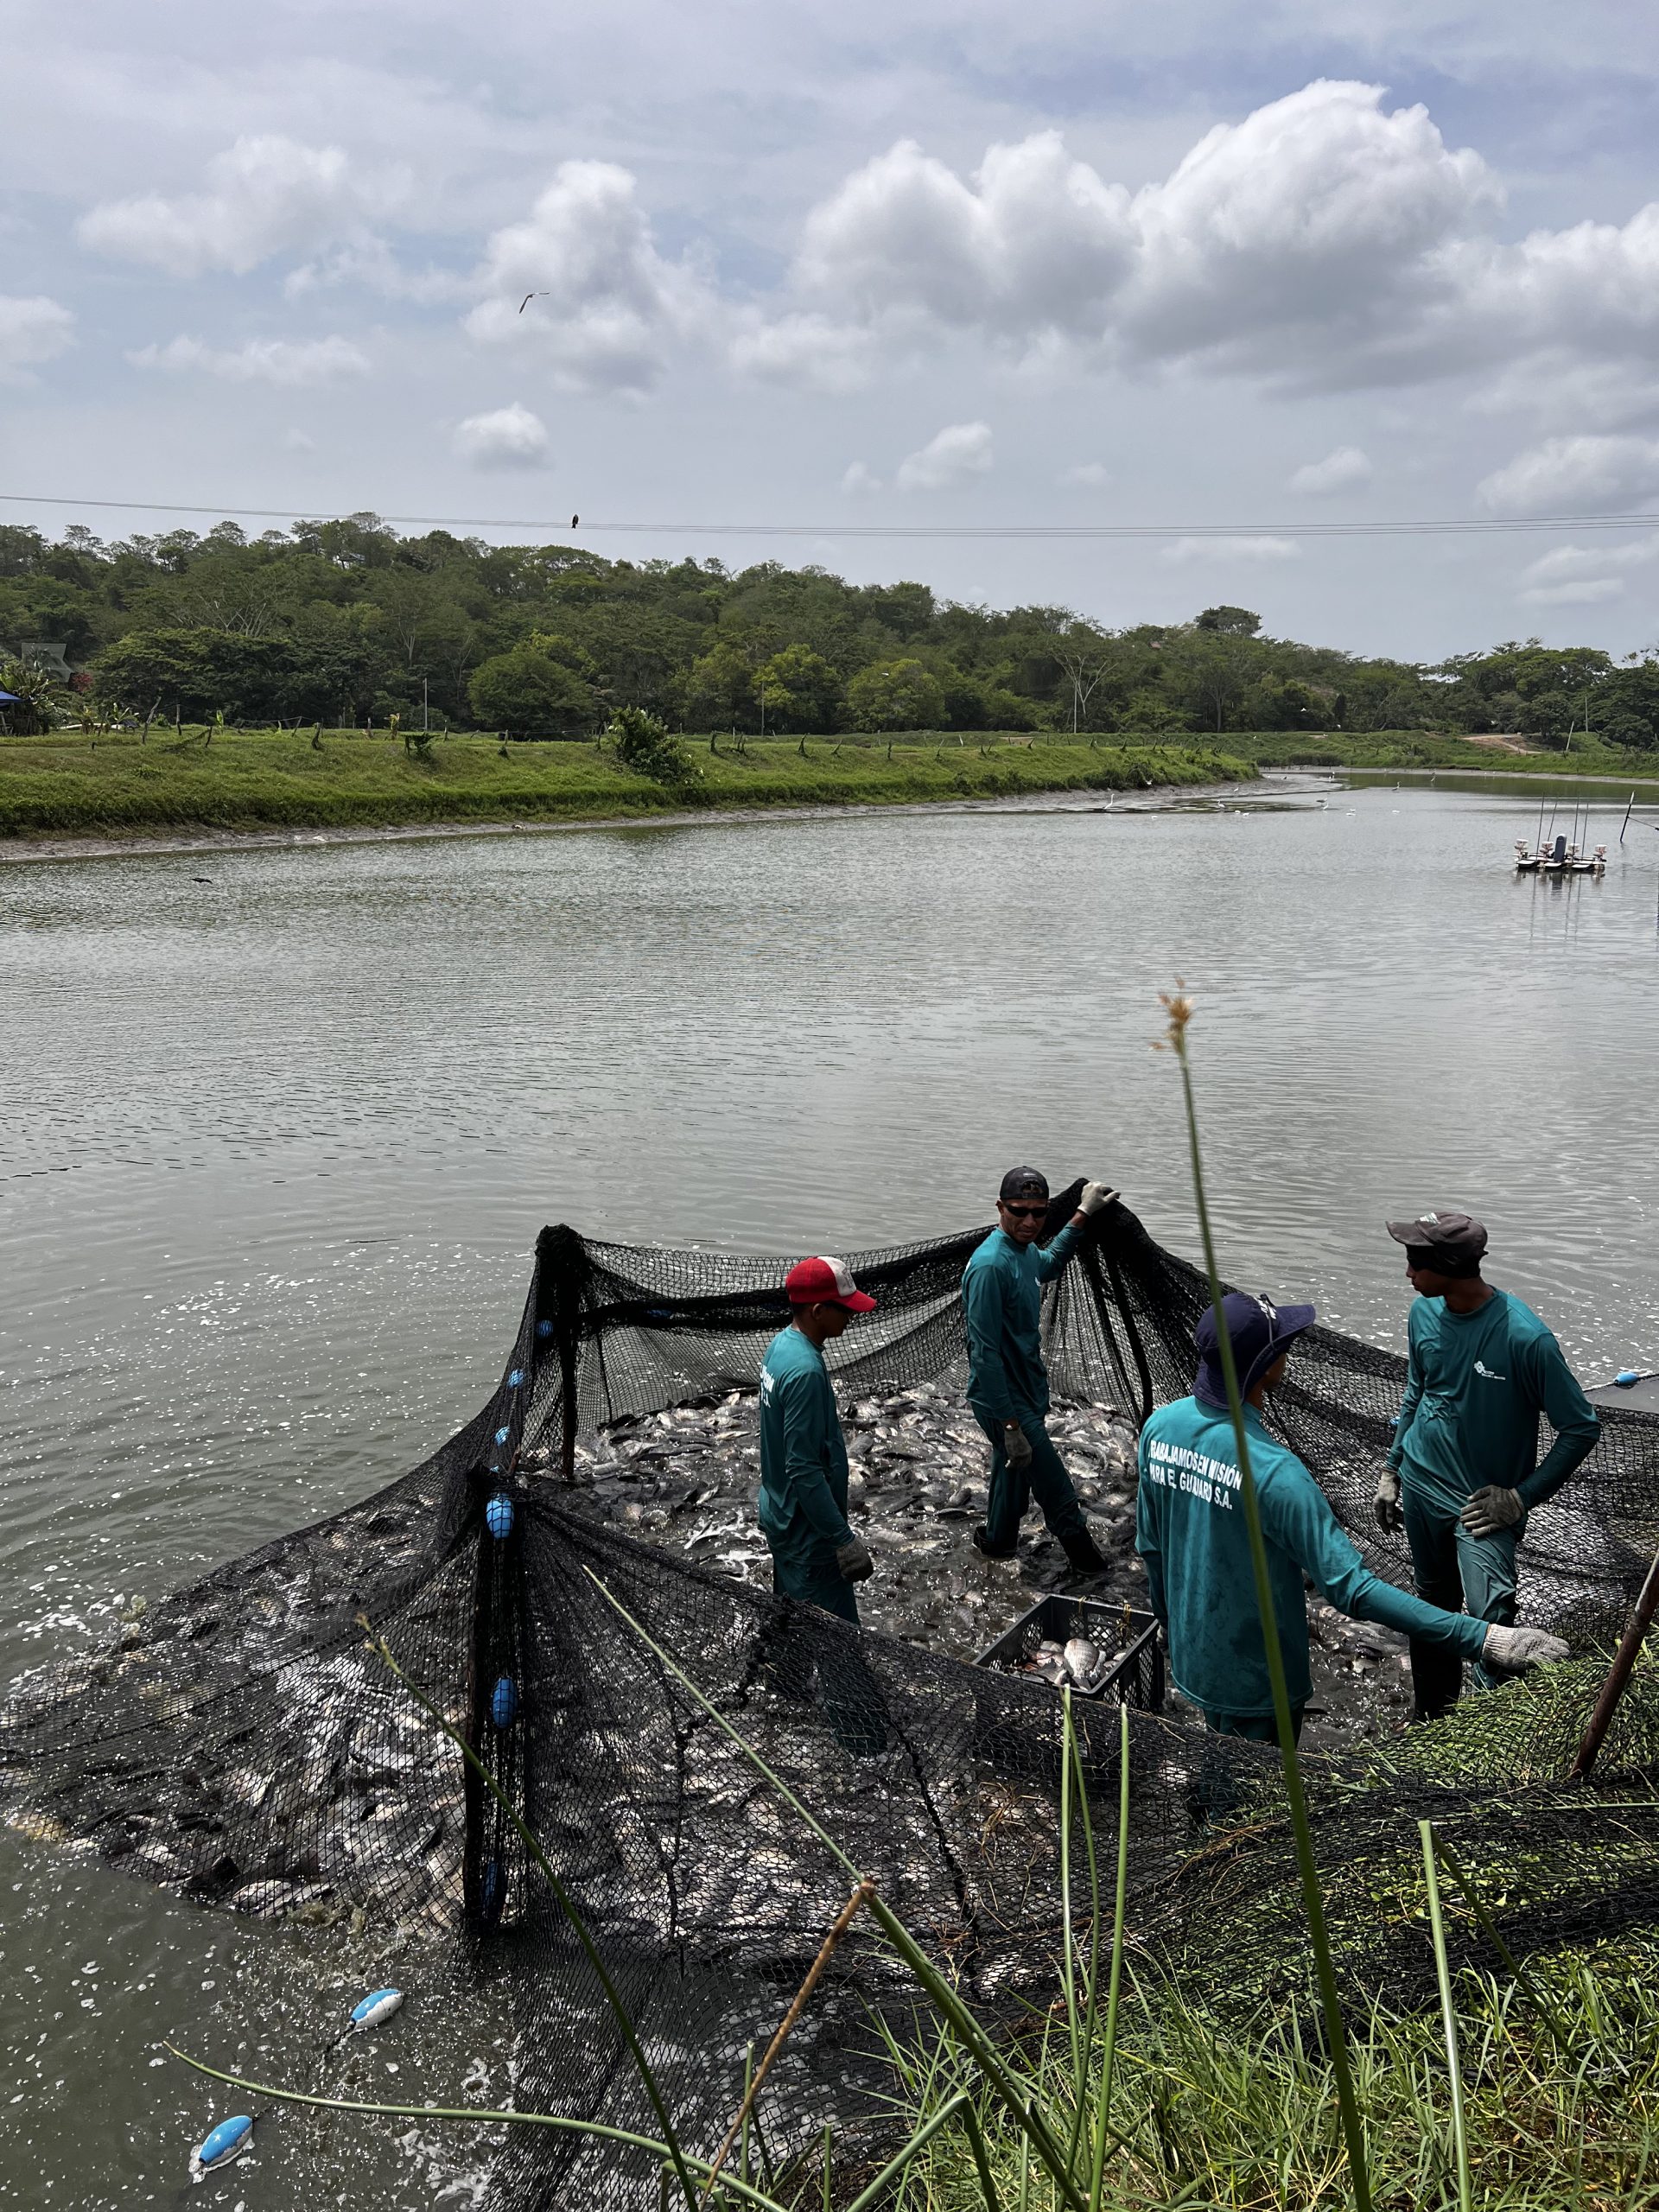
{"left": 1389, "top": 1289, "right": 1601, "bottom": 1510}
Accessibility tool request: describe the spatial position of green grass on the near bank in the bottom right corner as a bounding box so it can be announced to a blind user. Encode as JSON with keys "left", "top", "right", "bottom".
{"left": 898, "top": 1947, "right": 1659, "bottom": 2212}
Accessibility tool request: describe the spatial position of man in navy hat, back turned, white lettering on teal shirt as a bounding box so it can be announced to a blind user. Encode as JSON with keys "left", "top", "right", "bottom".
{"left": 1135, "top": 1289, "right": 1566, "bottom": 1743}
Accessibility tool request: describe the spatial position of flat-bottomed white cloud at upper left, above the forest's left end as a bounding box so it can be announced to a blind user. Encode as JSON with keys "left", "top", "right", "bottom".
{"left": 75, "top": 133, "right": 410, "bottom": 276}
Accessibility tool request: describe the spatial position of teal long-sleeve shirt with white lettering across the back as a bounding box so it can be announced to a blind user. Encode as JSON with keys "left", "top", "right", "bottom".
{"left": 1135, "top": 1398, "right": 1486, "bottom": 1714}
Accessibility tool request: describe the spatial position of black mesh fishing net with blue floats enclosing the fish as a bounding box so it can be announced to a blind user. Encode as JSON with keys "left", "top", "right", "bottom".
{"left": 0, "top": 1185, "right": 1659, "bottom": 2208}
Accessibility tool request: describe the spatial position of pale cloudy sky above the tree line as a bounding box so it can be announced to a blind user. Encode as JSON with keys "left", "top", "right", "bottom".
{"left": 0, "top": 0, "right": 1659, "bottom": 659}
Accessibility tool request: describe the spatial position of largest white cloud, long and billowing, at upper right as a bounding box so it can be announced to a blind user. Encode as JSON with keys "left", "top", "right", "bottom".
{"left": 794, "top": 79, "right": 1502, "bottom": 383}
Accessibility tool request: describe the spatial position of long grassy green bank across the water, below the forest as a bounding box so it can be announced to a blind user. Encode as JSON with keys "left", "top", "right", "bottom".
{"left": 0, "top": 730, "right": 1255, "bottom": 838}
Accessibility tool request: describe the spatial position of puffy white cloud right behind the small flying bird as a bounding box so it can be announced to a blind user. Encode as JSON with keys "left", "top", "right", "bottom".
{"left": 465, "top": 162, "right": 719, "bottom": 391}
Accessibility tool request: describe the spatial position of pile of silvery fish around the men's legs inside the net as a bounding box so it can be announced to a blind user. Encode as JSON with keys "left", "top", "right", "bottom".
{"left": 542, "top": 1374, "right": 1409, "bottom": 1747}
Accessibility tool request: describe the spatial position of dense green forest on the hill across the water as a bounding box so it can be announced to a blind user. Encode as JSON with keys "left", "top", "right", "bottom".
{"left": 0, "top": 515, "right": 1659, "bottom": 747}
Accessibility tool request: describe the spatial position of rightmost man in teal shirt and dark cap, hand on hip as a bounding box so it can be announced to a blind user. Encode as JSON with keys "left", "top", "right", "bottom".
{"left": 1376, "top": 1212, "right": 1601, "bottom": 1721}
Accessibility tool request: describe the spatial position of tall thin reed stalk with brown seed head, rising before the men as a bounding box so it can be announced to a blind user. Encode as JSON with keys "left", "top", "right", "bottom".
{"left": 1159, "top": 978, "right": 1371, "bottom": 2212}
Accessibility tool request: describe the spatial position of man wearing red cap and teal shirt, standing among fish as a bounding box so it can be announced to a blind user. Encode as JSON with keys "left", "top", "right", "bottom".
{"left": 761, "top": 1259, "right": 876, "bottom": 1628}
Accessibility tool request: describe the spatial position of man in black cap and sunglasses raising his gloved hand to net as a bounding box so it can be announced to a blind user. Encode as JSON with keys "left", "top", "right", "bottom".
{"left": 963, "top": 1168, "right": 1115, "bottom": 1575}
